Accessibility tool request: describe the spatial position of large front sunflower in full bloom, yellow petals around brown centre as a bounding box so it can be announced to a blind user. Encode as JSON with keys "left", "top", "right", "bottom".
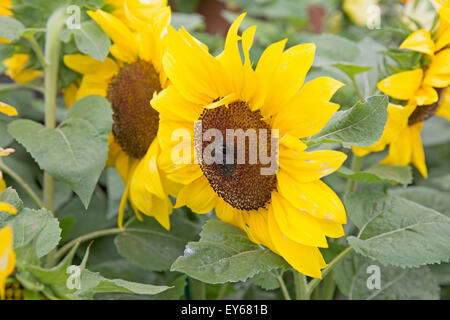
{"left": 151, "top": 14, "right": 346, "bottom": 278}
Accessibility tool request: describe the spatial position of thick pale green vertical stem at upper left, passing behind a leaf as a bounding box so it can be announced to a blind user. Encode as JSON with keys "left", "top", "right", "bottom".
{"left": 44, "top": 8, "right": 66, "bottom": 212}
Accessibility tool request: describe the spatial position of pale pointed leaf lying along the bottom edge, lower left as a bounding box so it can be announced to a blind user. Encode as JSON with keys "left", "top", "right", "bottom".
{"left": 69, "top": 270, "right": 171, "bottom": 299}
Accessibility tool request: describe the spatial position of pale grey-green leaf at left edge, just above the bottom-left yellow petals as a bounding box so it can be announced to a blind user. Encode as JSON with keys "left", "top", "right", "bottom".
{"left": 0, "top": 208, "right": 61, "bottom": 260}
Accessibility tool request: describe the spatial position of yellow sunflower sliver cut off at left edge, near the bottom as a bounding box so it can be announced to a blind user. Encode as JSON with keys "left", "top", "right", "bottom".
{"left": 0, "top": 226, "right": 16, "bottom": 300}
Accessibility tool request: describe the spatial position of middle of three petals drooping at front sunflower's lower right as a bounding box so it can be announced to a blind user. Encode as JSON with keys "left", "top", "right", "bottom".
{"left": 272, "top": 192, "right": 328, "bottom": 248}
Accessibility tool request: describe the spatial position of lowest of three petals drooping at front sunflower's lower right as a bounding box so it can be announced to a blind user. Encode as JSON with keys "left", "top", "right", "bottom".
{"left": 268, "top": 208, "right": 323, "bottom": 278}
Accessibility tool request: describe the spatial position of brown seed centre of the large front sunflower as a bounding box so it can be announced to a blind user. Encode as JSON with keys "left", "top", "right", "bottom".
{"left": 199, "top": 101, "right": 277, "bottom": 211}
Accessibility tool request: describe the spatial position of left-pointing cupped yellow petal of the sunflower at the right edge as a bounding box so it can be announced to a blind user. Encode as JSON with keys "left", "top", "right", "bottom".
{"left": 377, "top": 69, "right": 423, "bottom": 100}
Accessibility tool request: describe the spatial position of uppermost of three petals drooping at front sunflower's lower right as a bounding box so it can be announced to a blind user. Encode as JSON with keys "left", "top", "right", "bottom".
{"left": 277, "top": 169, "right": 347, "bottom": 224}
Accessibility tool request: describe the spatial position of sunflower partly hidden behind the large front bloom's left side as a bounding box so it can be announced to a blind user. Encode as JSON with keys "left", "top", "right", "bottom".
{"left": 64, "top": 2, "right": 176, "bottom": 229}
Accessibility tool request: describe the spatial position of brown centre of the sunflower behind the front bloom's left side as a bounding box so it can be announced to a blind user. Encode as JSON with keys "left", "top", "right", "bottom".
{"left": 108, "top": 60, "right": 161, "bottom": 159}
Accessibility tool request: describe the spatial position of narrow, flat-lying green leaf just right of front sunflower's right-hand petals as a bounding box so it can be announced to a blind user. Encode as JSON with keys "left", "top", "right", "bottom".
{"left": 337, "top": 164, "right": 412, "bottom": 185}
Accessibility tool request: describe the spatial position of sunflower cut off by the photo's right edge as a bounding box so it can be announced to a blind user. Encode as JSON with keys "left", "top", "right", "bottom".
{"left": 353, "top": 2, "right": 450, "bottom": 178}
